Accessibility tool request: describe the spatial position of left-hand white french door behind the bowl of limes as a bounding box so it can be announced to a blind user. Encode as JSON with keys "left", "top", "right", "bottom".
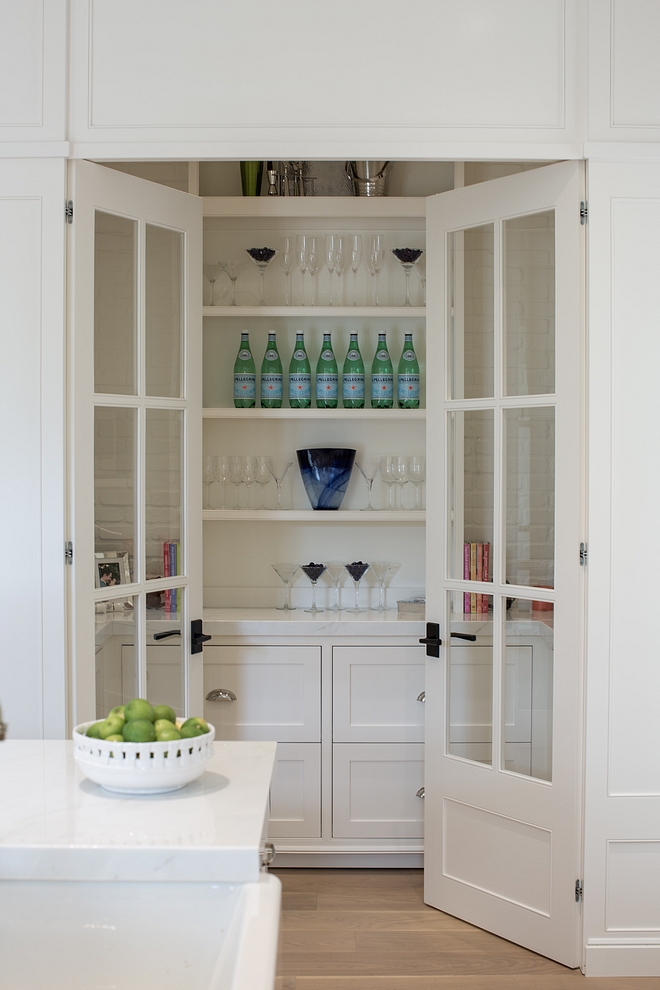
{"left": 68, "top": 161, "right": 203, "bottom": 724}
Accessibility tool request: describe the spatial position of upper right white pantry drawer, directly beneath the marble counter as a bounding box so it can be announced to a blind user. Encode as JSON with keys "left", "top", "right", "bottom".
{"left": 332, "top": 646, "right": 425, "bottom": 742}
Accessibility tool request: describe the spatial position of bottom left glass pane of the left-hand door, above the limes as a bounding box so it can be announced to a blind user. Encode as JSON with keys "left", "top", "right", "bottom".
{"left": 94, "top": 597, "right": 137, "bottom": 718}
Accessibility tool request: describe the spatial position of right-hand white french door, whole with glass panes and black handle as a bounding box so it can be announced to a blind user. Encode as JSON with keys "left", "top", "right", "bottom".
{"left": 425, "top": 162, "right": 585, "bottom": 966}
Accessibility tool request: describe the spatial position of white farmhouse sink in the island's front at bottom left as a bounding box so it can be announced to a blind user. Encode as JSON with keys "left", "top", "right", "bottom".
{"left": 0, "top": 873, "right": 281, "bottom": 990}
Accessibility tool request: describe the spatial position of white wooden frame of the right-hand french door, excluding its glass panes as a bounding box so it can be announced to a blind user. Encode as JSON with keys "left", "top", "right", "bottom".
{"left": 425, "top": 163, "right": 584, "bottom": 966}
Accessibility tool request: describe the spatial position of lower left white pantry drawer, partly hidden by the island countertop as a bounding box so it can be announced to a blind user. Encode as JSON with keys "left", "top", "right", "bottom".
{"left": 268, "top": 743, "right": 321, "bottom": 839}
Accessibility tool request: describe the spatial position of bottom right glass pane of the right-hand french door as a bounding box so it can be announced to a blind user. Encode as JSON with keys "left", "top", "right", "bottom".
{"left": 502, "top": 598, "right": 554, "bottom": 780}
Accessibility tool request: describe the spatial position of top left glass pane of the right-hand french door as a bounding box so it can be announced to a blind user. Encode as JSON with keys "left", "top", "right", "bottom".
{"left": 447, "top": 223, "right": 495, "bottom": 399}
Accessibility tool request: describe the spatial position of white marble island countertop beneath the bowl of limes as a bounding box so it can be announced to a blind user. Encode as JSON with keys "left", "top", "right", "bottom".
{"left": 0, "top": 740, "right": 276, "bottom": 883}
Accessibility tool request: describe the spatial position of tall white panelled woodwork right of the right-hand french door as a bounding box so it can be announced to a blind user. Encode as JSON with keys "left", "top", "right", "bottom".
{"left": 584, "top": 163, "right": 660, "bottom": 977}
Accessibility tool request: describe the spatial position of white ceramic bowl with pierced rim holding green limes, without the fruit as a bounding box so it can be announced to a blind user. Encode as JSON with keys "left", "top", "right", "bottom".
{"left": 73, "top": 719, "right": 215, "bottom": 794}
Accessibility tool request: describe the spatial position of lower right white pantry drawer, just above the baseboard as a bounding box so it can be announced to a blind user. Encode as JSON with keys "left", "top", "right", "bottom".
{"left": 332, "top": 743, "right": 424, "bottom": 839}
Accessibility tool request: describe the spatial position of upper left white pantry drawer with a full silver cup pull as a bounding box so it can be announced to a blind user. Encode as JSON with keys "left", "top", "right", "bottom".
{"left": 204, "top": 646, "right": 321, "bottom": 742}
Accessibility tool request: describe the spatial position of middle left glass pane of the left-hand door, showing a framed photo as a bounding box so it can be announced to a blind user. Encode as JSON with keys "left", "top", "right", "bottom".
{"left": 94, "top": 406, "right": 137, "bottom": 588}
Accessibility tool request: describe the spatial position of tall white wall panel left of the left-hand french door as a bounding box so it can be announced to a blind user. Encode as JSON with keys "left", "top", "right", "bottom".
{"left": 0, "top": 159, "right": 66, "bottom": 739}
